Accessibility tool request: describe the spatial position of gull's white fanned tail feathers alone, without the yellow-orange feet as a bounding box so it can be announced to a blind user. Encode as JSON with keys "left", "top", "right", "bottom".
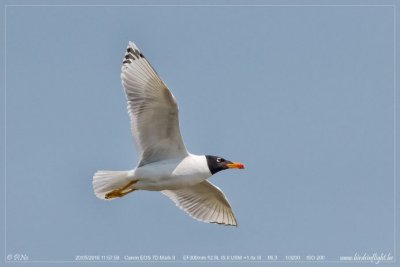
{"left": 93, "top": 171, "right": 132, "bottom": 200}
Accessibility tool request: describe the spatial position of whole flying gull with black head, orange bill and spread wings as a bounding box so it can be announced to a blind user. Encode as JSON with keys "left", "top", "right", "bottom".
{"left": 93, "top": 42, "right": 244, "bottom": 226}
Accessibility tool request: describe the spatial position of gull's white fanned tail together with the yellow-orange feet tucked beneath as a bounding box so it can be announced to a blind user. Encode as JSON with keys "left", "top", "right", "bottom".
{"left": 93, "top": 171, "right": 136, "bottom": 200}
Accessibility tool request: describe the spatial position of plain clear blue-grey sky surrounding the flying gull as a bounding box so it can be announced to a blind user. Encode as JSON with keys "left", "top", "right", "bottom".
{"left": 2, "top": 2, "right": 395, "bottom": 266}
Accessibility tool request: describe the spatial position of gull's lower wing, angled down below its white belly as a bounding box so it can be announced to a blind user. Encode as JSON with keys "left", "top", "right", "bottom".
{"left": 161, "top": 181, "right": 237, "bottom": 226}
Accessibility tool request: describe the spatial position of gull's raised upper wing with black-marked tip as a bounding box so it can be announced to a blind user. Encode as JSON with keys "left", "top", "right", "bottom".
{"left": 121, "top": 42, "right": 188, "bottom": 166}
